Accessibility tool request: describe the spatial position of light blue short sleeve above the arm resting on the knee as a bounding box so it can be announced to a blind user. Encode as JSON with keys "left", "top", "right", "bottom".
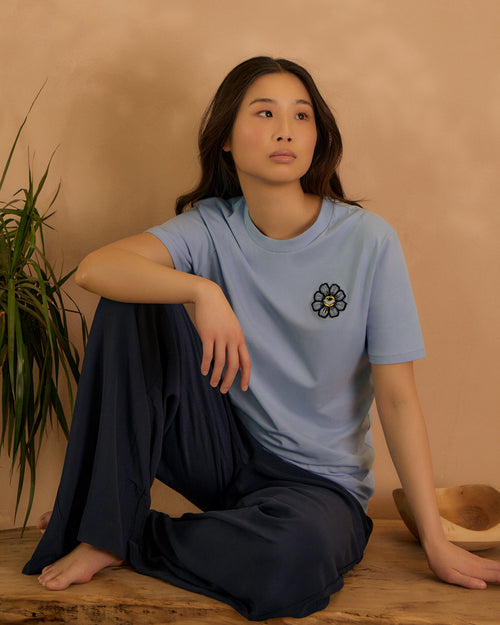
{"left": 146, "top": 209, "right": 212, "bottom": 275}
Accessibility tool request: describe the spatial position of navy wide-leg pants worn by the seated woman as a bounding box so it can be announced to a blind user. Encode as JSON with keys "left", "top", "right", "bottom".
{"left": 23, "top": 299, "right": 372, "bottom": 620}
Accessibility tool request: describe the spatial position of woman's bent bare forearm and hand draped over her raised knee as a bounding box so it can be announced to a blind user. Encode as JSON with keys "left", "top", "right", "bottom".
{"left": 75, "top": 233, "right": 251, "bottom": 393}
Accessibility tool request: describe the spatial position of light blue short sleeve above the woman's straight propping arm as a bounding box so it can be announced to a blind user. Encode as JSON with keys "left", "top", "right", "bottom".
{"left": 367, "top": 231, "right": 425, "bottom": 364}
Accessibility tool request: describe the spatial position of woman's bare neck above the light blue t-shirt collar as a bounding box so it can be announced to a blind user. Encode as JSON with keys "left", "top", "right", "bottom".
{"left": 242, "top": 183, "right": 321, "bottom": 239}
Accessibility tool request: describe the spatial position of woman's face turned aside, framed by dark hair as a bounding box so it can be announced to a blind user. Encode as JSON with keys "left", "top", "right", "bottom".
{"left": 224, "top": 73, "right": 317, "bottom": 188}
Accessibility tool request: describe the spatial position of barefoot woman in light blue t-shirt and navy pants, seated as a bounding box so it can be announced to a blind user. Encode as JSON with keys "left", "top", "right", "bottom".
{"left": 25, "top": 57, "right": 500, "bottom": 620}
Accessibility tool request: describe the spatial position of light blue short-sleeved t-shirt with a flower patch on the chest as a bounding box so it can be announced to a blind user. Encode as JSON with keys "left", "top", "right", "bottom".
{"left": 149, "top": 197, "right": 425, "bottom": 510}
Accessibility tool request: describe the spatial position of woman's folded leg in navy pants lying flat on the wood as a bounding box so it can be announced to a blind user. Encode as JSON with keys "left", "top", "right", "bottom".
{"left": 130, "top": 446, "right": 371, "bottom": 620}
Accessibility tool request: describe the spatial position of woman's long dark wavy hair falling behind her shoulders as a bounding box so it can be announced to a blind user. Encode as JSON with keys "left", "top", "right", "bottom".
{"left": 176, "top": 56, "right": 359, "bottom": 215}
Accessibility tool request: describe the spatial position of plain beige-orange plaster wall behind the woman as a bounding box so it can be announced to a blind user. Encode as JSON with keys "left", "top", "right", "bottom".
{"left": 0, "top": 0, "right": 500, "bottom": 528}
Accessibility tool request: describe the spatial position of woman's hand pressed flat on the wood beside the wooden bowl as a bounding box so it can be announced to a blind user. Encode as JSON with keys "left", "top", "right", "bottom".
{"left": 424, "top": 539, "right": 500, "bottom": 589}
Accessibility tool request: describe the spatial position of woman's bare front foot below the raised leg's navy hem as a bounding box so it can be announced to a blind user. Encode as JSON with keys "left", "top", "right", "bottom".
{"left": 38, "top": 543, "right": 124, "bottom": 590}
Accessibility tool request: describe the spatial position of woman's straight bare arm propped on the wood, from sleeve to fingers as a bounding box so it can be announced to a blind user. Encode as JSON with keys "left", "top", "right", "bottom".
{"left": 372, "top": 362, "right": 500, "bottom": 588}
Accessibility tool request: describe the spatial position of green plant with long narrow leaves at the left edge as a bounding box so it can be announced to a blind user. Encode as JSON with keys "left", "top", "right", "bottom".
{"left": 0, "top": 87, "right": 87, "bottom": 528}
